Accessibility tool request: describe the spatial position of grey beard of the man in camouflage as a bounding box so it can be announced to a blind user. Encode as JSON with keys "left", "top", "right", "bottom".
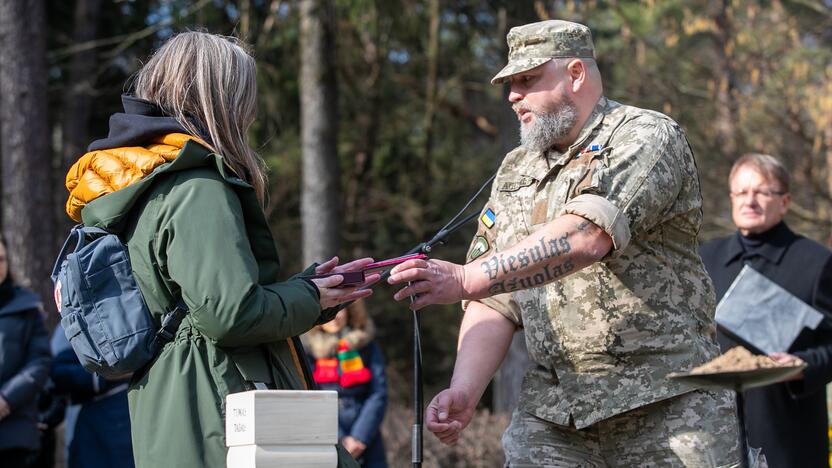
{"left": 515, "top": 98, "right": 578, "bottom": 152}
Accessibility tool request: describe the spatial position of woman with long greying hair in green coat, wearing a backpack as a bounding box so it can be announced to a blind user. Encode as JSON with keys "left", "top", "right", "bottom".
{"left": 67, "top": 32, "right": 378, "bottom": 467}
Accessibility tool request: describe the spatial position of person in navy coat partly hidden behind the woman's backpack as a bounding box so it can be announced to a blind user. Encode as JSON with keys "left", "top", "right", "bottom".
{"left": 51, "top": 325, "right": 135, "bottom": 468}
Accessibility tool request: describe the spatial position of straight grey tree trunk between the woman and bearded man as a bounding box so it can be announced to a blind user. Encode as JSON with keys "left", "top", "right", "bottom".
{"left": 300, "top": 0, "right": 340, "bottom": 264}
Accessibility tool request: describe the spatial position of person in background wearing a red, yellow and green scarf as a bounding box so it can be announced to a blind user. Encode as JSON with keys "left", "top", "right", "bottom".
{"left": 303, "top": 301, "right": 387, "bottom": 468}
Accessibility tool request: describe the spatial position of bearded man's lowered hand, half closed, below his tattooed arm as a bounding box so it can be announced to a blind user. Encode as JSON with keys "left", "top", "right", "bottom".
{"left": 425, "top": 388, "right": 477, "bottom": 445}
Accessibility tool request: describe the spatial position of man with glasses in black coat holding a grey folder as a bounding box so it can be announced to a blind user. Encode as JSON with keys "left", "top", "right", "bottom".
{"left": 700, "top": 154, "right": 832, "bottom": 468}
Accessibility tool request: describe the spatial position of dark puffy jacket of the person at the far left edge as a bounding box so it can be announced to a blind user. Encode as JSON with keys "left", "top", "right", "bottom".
{"left": 0, "top": 282, "right": 50, "bottom": 450}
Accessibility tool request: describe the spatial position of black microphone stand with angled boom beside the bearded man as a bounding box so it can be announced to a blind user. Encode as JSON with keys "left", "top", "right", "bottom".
{"left": 379, "top": 174, "right": 496, "bottom": 468}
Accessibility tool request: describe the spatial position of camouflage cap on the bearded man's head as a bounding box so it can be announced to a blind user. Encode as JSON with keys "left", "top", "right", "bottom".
{"left": 491, "top": 20, "right": 595, "bottom": 84}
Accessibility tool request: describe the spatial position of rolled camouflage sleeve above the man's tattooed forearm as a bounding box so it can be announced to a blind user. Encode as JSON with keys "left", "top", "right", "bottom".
{"left": 561, "top": 116, "right": 692, "bottom": 258}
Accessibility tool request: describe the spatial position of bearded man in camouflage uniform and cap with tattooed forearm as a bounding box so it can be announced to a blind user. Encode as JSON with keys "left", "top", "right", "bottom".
{"left": 390, "top": 20, "right": 739, "bottom": 467}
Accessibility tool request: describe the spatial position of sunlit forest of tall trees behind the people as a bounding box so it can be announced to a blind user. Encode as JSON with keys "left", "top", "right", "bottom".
{"left": 0, "top": 0, "right": 832, "bottom": 466}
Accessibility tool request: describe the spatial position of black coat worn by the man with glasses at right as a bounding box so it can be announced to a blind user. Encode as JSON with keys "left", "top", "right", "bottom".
{"left": 700, "top": 223, "right": 832, "bottom": 468}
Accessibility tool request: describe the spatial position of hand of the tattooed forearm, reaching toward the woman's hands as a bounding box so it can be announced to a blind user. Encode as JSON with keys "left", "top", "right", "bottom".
{"left": 387, "top": 260, "right": 469, "bottom": 310}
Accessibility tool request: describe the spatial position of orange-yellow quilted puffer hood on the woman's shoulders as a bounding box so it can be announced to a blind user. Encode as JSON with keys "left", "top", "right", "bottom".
{"left": 66, "top": 133, "right": 202, "bottom": 222}
